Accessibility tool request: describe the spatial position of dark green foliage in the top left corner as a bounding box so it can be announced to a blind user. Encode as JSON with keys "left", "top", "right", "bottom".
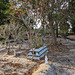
{"left": 0, "top": 0, "right": 9, "bottom": 25}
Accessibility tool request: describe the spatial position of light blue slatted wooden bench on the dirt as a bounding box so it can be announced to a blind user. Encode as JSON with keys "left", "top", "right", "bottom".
{"left": 28, "top": 46, "right": 48, "bottom": 60}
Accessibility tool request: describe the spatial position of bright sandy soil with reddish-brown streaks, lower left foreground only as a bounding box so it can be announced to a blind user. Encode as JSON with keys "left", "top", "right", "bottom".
{"left": 0, "top": 55, "right": 36, "bottom": 75}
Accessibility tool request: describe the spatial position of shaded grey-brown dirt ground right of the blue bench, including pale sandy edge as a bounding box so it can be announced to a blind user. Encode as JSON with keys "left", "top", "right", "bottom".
{"left": 32, "top": 38, "right": 75, "bottom": 75}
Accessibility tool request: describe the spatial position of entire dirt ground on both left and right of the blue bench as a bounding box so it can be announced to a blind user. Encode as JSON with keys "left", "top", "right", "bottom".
{"left": 0, "top": 38, "right": 75, "bottom": 75}
